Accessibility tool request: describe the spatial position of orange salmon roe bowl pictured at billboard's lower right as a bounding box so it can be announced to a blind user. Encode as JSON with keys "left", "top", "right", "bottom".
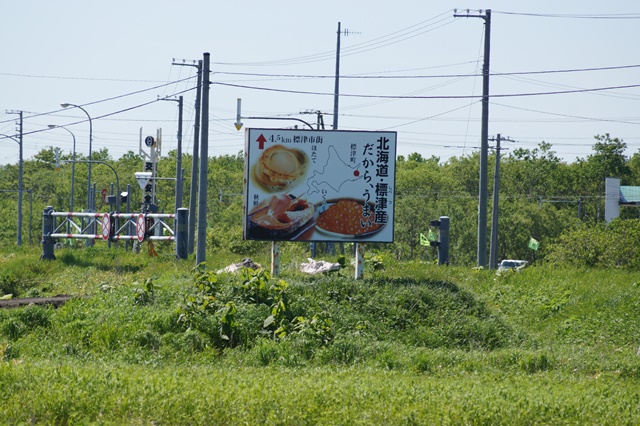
{"left": 316, "top": 199, "right": 383, "bottom": 236}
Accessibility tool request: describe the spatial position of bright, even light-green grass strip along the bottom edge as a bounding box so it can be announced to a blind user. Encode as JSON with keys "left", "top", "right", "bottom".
{"left": 0, "top": 361, "right": 640, "bottom": 425}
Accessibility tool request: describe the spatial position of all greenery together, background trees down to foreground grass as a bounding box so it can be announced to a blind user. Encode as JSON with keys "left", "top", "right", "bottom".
{"left": 0, "top": 134, "right": 640, "bottom": 425}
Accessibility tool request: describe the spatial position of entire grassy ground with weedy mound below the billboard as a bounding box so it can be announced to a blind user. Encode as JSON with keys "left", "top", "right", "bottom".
{"left": 0, "top": 247, "right": 640, "bottom": 425}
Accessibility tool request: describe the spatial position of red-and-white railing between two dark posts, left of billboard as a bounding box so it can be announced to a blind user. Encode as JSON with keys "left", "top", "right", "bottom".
{"left": 41, "top": 206, "right": 189, "bottom": 260}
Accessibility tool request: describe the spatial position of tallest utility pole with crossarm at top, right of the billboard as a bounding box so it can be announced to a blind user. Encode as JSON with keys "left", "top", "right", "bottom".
{"left": 453, "top": 9, "right": 491, "bottom": 267}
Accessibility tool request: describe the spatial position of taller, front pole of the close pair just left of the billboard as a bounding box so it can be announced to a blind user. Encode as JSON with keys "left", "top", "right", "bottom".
{"left": 196, "top": 52, "right": 210, "bottom": 266}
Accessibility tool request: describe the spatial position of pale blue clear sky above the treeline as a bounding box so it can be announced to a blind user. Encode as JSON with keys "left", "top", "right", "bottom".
{"left": 0, "top": 0, "right": 640, "bottom": 167}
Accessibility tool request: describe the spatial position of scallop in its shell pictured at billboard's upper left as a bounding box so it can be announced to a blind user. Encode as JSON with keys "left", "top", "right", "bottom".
{"left": 253, "top": 145, "right": 309, "bottom": 192}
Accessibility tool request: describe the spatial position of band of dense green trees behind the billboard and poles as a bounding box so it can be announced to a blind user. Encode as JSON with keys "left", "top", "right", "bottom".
{"left": 0, "top": 134, "right": 640, "bottom": 265}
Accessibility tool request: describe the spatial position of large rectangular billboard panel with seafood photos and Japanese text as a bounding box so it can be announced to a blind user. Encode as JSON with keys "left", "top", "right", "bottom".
{"left": 243, "top": 129, "right": 397, "bottom": 243}
